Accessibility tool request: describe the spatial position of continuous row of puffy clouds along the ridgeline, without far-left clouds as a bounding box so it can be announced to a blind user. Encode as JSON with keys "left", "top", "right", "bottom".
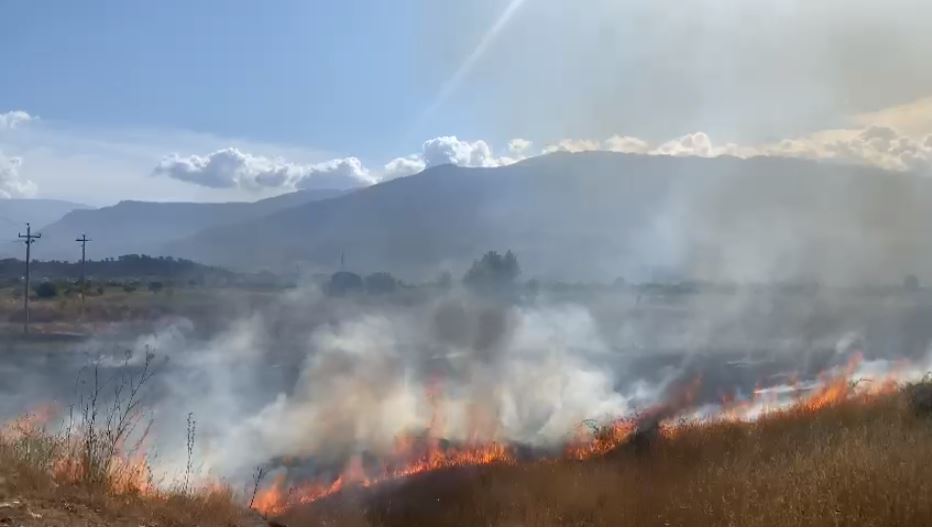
{"left": 154, "top": 120, "right": 932, "bottom": 195}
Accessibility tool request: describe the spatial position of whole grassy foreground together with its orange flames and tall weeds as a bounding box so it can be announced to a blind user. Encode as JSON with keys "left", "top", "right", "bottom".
{"left": 0, "top": 340, "right": 932, "bottom": 525}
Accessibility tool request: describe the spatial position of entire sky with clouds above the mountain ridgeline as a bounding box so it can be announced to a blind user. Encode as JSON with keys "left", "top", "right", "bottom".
{"left": 0, "top": 0, "right": 932, "bottom": 205}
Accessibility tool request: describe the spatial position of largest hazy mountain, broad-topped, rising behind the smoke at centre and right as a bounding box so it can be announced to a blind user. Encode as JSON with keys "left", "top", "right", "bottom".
{"left": 164, "top": 152, "right": 932, "bottom": 282}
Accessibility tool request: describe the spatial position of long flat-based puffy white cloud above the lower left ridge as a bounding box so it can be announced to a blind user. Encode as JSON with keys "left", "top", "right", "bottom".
{"left": 154, "top": 147, "right": 375, "bottom": 191}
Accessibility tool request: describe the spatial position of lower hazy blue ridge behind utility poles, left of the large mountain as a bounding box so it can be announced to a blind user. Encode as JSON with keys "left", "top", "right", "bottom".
{"left": 26, "top": 190, "right": 343, "bottom": 260}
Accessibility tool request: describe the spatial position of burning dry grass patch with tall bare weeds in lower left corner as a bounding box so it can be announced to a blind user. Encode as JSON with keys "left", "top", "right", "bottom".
{"left": 0, "top": 355, "right": 261, "bottom": 525}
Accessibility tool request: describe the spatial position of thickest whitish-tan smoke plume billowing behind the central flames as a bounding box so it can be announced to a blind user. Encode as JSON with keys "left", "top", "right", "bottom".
{"left": 172, "top": 288, "right": 650, "bottom": 475}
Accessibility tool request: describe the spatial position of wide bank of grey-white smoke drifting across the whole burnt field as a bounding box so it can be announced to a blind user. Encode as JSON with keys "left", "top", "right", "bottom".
{"left": 0, "top": 262, "right": 932, "bottom": 490}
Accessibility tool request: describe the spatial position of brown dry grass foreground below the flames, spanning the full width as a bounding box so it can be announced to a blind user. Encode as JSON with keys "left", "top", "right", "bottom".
{"left": 0, "top": 383, "right": 932, "bottom": 525}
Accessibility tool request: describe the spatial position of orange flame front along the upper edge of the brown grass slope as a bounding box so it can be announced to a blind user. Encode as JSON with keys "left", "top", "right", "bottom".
{"left": 254, "top": 354, "right": 906, "bottom": 515}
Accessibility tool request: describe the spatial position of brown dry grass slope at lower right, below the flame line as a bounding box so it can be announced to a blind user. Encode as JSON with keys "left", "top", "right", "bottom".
{"left": 282, "top": 389, "right": 932, "bottom": 525}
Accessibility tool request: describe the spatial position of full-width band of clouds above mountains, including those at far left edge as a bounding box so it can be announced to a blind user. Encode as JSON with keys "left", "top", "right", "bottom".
{"left": 9, "top": 93, "right": 932, "bottom": 197}
